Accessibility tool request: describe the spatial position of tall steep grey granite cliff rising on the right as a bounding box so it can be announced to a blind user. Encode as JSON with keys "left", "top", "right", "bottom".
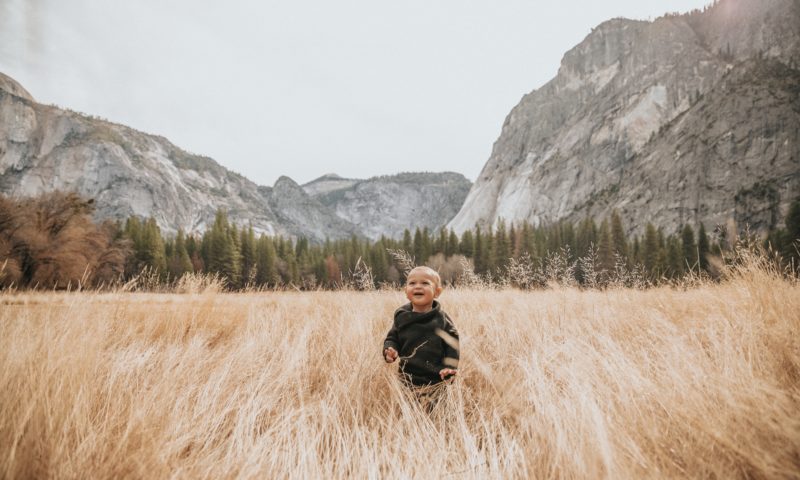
{"left": 449, "top": 0, "right": 800, "bottom": 233}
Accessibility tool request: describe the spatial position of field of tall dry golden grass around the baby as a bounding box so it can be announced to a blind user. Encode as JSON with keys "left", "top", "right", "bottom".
{"left": 0, "top": 269, "right": 800, "bottom": 478}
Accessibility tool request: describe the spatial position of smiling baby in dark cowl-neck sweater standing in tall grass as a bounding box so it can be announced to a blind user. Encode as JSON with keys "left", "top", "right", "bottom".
{"left": 383, "top": 267, "right": 458, "bottom": 387}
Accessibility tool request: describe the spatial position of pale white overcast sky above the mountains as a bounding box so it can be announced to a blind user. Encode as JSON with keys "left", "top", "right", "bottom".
{"left": 0, "top": 0, "right": 709, "bottom": 185}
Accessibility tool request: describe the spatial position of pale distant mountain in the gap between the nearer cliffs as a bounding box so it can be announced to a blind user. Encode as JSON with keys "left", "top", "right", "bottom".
{"left": 303, "top": 172, "right": 472, "bottom": 239}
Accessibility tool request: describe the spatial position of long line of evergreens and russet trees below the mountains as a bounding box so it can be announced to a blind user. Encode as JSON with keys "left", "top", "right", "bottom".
{"left": 0, "top": 192, "right": 800, "bottom": 290}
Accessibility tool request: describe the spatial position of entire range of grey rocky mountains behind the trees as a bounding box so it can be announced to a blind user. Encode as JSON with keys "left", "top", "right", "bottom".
{"left": 0, "top": 0, "right": 800, "bottom": 241}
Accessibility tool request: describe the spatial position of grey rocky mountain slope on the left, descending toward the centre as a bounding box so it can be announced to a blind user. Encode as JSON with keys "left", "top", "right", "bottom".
{"left": 0, "top": 84, "right": 286, "bottom": 238}
